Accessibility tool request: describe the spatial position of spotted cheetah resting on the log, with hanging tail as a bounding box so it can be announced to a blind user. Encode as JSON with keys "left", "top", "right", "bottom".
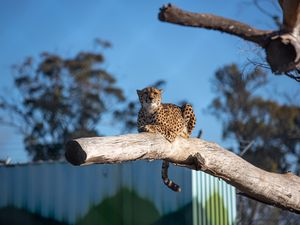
{"left": 137, "top": 87, "right": 196, "bottom": 192}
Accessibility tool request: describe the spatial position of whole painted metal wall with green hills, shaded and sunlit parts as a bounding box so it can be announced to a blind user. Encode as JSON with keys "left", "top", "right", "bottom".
{"left": 0, "top": 161, "right": 235, "bottom": 225}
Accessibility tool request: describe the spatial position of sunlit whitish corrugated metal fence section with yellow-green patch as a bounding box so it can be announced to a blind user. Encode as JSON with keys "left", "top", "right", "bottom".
{"left": 192, "top": 171, "right": 236, "bottom": 225}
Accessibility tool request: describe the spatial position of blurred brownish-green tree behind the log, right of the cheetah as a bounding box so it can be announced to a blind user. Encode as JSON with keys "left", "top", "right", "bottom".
{"left": 209, "top": 64, "right": 300, "bottom": 224}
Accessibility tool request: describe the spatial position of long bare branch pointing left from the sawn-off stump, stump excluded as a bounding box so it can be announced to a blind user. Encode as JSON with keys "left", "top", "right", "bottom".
{"left": 158, "top": 4, "right": 274, "bottom": 46}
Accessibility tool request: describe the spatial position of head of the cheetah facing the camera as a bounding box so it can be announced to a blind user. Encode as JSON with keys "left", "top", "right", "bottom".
{"left": 136, "top": 87, "right": 162, "bottom": 111}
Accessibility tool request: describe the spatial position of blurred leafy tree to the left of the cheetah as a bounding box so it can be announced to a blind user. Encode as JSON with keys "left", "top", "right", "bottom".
{"left": 0, "top": 40, "right": 125, "bottom": 160}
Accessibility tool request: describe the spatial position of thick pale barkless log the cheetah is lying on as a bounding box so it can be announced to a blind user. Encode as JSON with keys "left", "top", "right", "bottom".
{"left": 65, "top": 133, "right": 300, "bottom": 213}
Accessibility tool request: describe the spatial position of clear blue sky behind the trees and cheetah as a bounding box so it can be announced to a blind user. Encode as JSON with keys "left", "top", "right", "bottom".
{"left": 0, "top": 0, "right": 299, "bottom": 162}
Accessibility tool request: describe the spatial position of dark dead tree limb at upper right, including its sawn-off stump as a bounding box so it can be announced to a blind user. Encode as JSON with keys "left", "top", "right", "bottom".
{"left": 158, "top": 3, "right": 300, "bottom": 74}
